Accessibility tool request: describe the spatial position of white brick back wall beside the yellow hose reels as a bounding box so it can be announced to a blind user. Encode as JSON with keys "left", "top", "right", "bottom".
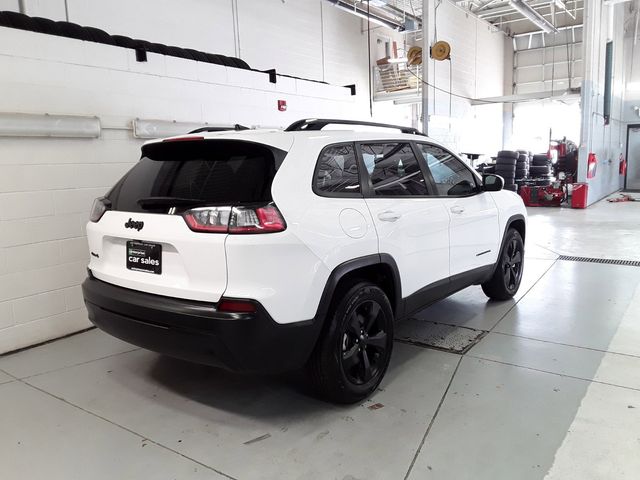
{"left": 372, "top": 1, "right": 511, "bottom": 154}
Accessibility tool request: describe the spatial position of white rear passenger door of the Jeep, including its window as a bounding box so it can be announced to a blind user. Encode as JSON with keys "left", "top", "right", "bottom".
{"left": 359, "top": 141, "right": 449, "bottom": 306}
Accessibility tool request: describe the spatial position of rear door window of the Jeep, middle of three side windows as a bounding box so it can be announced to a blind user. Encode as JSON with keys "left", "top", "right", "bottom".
{"left": 361, "top": 143, "right": 428, "bottom": 196}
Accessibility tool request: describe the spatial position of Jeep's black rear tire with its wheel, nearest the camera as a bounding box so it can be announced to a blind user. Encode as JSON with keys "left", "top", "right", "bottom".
{"left": 307, "top": 282, "right": 393, "bottom": 403}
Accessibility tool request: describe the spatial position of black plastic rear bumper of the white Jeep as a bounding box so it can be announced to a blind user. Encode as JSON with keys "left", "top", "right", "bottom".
{"left": 82, "top": 274, "right": 321, "bottom": 373}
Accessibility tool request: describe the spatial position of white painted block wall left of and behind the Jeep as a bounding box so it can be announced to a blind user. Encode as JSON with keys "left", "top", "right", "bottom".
{"left": 0, "top": 0, "right": 368, "bottom": 353}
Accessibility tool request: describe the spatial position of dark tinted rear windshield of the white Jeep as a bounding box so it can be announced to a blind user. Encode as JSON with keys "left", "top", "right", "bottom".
{"left": 107, "top": 140, "right": 285, "bottom": 213}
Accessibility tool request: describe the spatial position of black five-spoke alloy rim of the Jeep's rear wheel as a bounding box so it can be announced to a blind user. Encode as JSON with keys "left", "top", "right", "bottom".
{"left": 342, "top": 300, "right": 387, "bottom": 385}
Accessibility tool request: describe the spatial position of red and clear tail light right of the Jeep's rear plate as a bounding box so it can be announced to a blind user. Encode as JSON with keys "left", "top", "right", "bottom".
{"left": 182, "top": 203, "right": 287, "bottom": 233}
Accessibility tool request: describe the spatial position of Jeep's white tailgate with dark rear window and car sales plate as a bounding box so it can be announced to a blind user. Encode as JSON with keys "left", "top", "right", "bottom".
{"left": 87, "top": 139, "right": 286, "bottom": 302}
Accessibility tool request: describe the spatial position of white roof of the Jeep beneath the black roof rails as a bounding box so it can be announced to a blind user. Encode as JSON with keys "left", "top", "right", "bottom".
{"left": 145, "top": 128, "right": 446, "bottom": 151}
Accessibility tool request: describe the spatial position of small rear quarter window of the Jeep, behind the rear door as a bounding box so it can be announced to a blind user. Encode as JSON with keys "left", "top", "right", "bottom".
{"left": 314, "top": 144, "right": 360, "bottom": 194}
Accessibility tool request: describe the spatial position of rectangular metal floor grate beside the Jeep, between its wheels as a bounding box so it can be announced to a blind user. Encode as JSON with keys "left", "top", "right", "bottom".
{"left": 395, "top": 318, "right": 487, "bottom": 354}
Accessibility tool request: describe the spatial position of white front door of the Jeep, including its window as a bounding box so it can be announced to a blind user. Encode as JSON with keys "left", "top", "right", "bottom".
{"left": 417, "top": 143, "right": 500, "bottom": 277}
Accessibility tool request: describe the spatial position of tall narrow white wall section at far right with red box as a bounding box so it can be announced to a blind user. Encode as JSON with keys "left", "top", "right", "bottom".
{"left": 578, "top": 2, "right": 626, "bottom": 204}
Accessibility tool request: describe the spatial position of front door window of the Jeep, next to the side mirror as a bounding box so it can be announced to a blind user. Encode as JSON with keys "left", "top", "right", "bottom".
{"left": 418, "top": 143, "right": 478, "bottom": 196}
